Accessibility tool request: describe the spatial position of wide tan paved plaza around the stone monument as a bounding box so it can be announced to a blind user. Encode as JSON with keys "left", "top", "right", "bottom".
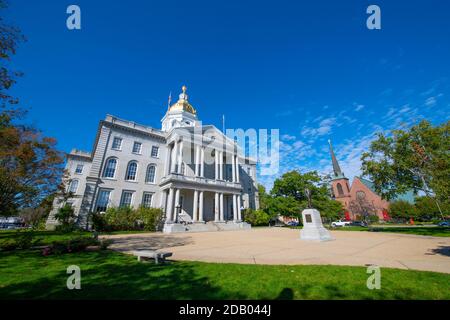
{"left": 104, "top": 228, "right": 450, "bottom": 273}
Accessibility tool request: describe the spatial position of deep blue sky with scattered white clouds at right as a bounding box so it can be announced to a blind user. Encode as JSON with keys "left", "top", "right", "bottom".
{"left": 3, "top": 0, "right": 450, "bottom": 187}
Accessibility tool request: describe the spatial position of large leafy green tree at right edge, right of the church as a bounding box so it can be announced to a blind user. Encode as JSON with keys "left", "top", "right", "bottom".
{"left": 361, "top": 120, "right": 450, "bottom": 219}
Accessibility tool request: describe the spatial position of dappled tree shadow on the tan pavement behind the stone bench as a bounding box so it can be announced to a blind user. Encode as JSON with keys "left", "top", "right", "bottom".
{"left": 110, "top": 235, "right": 194, "bottom": 252}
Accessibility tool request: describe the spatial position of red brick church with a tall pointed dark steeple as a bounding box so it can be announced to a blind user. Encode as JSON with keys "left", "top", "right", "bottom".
{"left": 328, "top": 141, "right": 413, "bottom": 220}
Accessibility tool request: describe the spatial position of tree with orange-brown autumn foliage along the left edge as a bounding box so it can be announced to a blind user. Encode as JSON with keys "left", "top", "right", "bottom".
{"left": 0, "top": 0, "right": 63, "bottom": 215}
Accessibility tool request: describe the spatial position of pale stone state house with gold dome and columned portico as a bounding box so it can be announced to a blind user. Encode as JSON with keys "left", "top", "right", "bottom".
{"left": 47, "top": 86, "right": 259, "bottom": 232}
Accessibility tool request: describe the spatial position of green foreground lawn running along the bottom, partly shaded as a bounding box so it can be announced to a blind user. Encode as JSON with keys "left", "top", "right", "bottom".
{"left": 0, "top": 250, "right": 450, "bottom": 299}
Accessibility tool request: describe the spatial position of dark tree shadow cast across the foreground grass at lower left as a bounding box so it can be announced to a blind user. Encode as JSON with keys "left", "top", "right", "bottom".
{"left": 0, "top": 252, "right": 246, "bottom": 300}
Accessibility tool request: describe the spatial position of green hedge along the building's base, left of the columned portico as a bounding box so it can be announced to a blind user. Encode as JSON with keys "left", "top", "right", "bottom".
{"left": 92, "top": 207, "right": 163, "bottom": 231}
